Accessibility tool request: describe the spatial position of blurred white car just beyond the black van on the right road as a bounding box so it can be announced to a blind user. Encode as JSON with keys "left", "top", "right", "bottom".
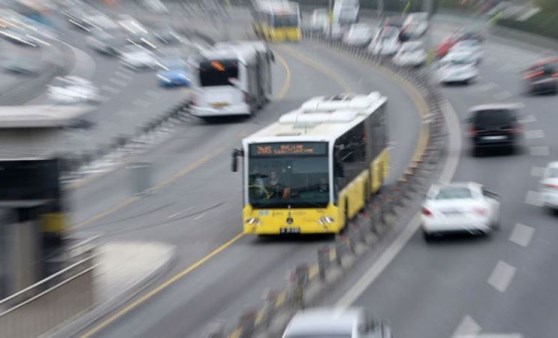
{"left": 434, "top": 52, "right": 479, "bottom": 84}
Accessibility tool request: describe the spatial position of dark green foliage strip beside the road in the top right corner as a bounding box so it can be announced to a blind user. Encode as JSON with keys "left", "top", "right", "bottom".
{"left": 498, "top": 10, "right": 558, "bottom": 39}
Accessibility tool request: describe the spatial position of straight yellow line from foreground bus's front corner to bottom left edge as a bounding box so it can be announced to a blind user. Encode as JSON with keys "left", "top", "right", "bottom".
{"left": 82, "top": 233, "right": 244, "bottom": 338}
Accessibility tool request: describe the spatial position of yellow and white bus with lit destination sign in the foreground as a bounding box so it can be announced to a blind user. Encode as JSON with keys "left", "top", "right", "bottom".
{"left": 232, "top": 92, "right": 389, "bottom": 235}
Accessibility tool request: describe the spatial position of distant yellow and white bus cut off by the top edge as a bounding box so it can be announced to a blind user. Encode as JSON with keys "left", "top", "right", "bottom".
{"left": 252, "top": 0, "right": 302, "bottom": 41}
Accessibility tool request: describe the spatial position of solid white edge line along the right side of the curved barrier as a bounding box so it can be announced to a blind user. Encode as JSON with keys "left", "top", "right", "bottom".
{"left": 336, "top": 101, "right": 462, "bottom": 307}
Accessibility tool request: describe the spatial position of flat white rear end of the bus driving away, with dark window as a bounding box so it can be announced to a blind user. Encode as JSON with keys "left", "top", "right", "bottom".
{"left": 191, "top": 59, "right": 252, "bottom": 117}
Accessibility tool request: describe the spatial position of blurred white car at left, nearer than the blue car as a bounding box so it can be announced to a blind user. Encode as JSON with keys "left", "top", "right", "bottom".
{"left": 48, "top": 76, "right": 100, "bottom": 104}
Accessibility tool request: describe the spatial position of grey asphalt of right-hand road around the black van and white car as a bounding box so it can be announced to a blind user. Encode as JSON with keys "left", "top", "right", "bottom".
{"left": 324, "top": 17, "right": 558, "bottom": 338}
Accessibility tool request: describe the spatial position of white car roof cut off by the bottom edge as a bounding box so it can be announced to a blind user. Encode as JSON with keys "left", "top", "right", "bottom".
{"left": 282, "top": 308, "right": 392, "bottom": 338}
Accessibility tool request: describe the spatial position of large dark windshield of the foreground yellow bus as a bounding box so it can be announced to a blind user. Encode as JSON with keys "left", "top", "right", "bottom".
{"left": 248, "top": 143, "right": 330, "bottom": 208}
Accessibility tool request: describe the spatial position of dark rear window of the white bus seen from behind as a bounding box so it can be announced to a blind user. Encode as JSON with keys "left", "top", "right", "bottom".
{"left": 199, "top": 60, "right": 238, "bottom": 87}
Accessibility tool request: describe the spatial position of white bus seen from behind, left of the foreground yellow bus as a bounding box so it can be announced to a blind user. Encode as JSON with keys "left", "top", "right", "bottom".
{"left": 191, "top": 41, "right": 275, "bottom": 118}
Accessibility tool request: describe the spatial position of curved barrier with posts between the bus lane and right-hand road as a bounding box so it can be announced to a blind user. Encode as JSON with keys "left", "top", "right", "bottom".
{"left": 210, "top": 32, "right": 447, "bottom": 338}
